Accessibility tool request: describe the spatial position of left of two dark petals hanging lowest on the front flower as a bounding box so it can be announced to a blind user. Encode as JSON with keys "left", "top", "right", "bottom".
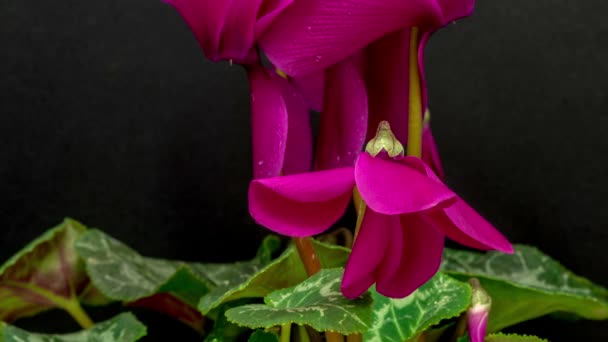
{"left": 341, "top": 208, "right": 400, "bottom": 299}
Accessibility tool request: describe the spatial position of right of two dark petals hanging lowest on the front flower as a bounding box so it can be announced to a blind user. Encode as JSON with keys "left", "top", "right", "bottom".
{"left": 376, "top": 214, "right": 444, "bottom": 298}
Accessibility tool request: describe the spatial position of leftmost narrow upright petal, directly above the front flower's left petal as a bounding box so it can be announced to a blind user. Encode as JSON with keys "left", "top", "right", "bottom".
{"left": 247, "top": 65, "right": 288, "bottom": 179}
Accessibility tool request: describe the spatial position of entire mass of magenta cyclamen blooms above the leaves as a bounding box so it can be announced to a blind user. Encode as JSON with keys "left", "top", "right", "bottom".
{"left": 166, "top": 0, "right": 512, "bottom": 298}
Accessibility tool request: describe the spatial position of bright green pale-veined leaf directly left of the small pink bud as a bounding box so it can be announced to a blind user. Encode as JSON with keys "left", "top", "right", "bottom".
{"left": 364, "top": 273, "right": 471, "bottom": 342}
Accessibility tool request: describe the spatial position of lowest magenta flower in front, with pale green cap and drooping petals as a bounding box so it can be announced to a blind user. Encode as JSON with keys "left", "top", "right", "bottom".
{"left": 249, "top": 122, "right": 512, "bottom": 298}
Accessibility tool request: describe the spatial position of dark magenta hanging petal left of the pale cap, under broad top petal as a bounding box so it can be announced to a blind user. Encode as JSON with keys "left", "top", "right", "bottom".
{"left": 315, "top": 57, "right": 368, "bottom": 170}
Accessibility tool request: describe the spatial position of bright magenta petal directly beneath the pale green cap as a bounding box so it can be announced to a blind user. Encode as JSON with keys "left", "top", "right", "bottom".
{"left": 355, "top": 153, "right": 457, "bottom": 215}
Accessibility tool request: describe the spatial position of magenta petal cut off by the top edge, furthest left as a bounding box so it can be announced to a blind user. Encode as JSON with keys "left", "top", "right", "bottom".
{"left": 165, "top": 0, "right": 264, "bottom": 63}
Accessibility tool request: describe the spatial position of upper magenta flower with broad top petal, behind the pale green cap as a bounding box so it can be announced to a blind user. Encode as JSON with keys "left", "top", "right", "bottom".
{"left": 259, "top": 0, "right": 474, "bottom": 174}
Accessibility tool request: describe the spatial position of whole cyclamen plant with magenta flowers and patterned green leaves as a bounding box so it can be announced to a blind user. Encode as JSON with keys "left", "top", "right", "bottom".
{"left": 0, "top": 0, "right": 608, "bottom": 342}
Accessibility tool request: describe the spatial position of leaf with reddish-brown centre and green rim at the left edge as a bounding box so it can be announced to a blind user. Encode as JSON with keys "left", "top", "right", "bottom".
{"left": 0, "top": 219, "right": 89, "bottom": 323}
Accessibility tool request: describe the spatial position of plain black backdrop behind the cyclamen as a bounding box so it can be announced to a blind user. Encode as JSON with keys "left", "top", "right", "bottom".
{"left": 0, "top": 0, "right": 608, "bottom": 341}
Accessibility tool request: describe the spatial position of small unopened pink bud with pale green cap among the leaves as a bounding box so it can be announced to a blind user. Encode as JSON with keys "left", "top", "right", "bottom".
{"left": 467, "top": 278, "right": 492, "bottom": 342}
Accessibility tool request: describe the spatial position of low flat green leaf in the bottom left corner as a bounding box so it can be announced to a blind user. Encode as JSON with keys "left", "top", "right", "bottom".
{"left": 0, "top": 313, "right": 146, "bottom": 342}
